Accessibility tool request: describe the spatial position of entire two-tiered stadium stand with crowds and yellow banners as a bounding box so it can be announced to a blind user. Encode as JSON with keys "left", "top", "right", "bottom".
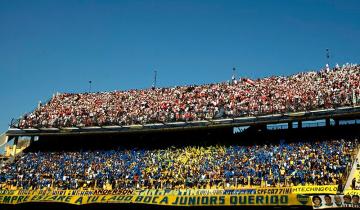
{"left": 0, "top": 64, "right": 360, "bottom": 208}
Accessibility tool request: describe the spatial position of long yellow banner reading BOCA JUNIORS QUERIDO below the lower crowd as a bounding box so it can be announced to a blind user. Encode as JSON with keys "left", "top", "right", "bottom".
{"left": 0, "top": 194, "right": 311, "bottom": 206}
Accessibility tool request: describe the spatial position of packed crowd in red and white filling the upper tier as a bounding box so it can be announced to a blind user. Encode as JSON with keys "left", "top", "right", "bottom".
{"left": 12, "top": 64, "right": 360, "bottom": 128}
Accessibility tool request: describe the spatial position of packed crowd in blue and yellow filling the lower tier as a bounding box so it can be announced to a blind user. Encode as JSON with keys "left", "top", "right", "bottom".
{"left": 0, "top": 139, "right": 358, "bottom": 189}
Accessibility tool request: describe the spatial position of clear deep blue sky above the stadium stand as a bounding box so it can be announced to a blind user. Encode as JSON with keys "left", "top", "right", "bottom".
{"left": 0, "top": 0, "right": 360, "bottom": 133}
